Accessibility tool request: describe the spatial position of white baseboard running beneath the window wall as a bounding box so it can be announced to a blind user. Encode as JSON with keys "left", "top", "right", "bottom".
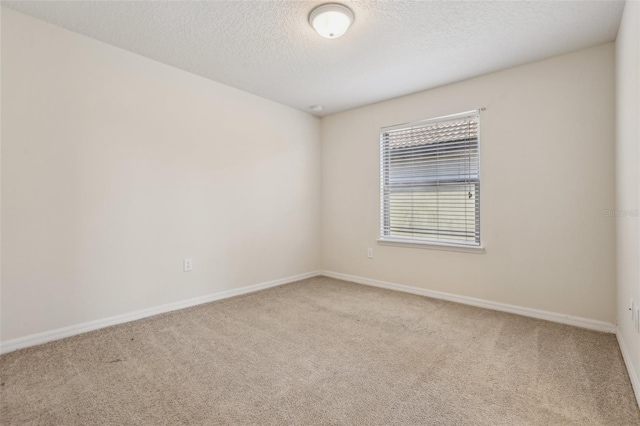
{"left": 320, "top": 271, "right": 616, "bottom": 333}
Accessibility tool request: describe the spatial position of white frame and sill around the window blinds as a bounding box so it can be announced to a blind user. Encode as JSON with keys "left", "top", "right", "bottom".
{"left": 378, "top": 110, "right": 484, "bottom": 253}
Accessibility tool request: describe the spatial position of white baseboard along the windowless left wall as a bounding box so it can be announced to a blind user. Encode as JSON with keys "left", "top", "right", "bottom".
{"left": 0, "top": 271, "right": 320, "bottom": 354}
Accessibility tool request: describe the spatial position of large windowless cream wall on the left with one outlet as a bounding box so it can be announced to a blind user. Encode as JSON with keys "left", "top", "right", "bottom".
{"left": 1, "top": 8, "right": 320, "bottom": 341}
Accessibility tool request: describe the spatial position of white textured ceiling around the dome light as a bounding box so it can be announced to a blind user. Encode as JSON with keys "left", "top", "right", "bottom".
{"left": 2, "top": 0, "right": 624, "bottom": 115}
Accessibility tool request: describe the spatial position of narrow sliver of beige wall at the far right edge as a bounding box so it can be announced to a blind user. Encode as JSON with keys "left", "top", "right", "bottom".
{"left": 616, "top": 1, "right": 640, "bottom": 397}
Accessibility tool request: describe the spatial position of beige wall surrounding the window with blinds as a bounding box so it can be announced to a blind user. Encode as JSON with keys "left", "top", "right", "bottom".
{"left": 322, "top": 43, "right": 616, "bottom": 323}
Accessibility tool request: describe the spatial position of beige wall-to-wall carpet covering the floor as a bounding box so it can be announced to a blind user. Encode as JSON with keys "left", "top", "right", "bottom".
{"left": 0, "top": 277, "right": 640, "bottom": 426}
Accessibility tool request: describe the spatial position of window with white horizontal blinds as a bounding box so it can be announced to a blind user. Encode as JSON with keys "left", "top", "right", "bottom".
{"left": 380, "top": 111, "right": 480, "bottom": 247}
